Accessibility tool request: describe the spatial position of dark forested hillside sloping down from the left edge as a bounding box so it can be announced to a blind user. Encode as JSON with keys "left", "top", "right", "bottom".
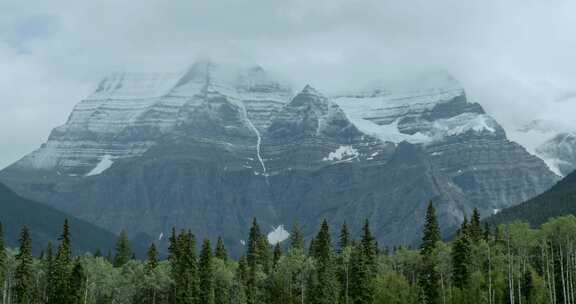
{"left": 0, "top": 184, "right": 128, "bottom": 253}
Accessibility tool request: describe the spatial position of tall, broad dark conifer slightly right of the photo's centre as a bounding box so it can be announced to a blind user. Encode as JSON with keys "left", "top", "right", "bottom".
{"left": 309, "top": 220, "right": 339, "bottom": 304}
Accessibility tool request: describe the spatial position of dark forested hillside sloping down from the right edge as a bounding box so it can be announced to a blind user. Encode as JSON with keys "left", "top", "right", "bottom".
{"left": 487, "top": 172, "right": 576, "bottom": 227}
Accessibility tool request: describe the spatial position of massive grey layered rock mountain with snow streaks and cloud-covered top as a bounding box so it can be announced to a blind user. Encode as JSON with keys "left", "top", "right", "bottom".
{"left": 0, "top": 62, "right": 557, "bottom": 253}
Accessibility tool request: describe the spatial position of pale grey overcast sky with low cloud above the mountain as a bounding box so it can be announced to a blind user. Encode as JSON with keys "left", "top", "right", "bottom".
{"left": 0, "top": 0, "right": 576, "bottom": 168}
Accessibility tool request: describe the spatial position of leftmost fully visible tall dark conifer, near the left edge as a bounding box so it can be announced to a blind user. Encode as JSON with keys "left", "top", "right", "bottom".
{"left": 14, "top": 226, "right": 34, "bottom": 304}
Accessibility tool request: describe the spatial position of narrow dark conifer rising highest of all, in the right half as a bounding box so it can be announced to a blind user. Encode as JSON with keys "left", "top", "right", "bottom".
{"left": 419, "top": 202, "right": 441, "bottom": 304}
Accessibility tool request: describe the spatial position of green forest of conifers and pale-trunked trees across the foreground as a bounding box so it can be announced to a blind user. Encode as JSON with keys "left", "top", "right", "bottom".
{"left": 0, "top": 203, "right": 576, "bottom": 304}
